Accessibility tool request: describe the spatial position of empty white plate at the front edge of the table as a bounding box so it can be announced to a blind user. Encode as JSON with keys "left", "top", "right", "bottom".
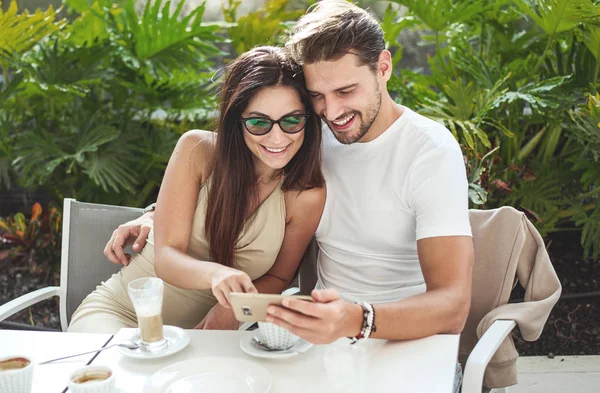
{"left": 143, "top": 357, "right": 272, "bottom": 393}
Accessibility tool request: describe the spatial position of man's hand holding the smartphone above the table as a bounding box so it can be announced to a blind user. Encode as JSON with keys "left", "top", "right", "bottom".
{"left": 267, "top": 289, "right": 363, "bottom": 344}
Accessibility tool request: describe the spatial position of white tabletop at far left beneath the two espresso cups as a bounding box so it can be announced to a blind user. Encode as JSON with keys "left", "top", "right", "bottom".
{"left": 0, "top": 330, "right": 112, "bottom": 393}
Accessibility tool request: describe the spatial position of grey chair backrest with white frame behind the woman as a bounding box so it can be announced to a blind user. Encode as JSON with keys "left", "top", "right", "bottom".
{"left": 60, "top": 198, "right": 142, "bottom": 330}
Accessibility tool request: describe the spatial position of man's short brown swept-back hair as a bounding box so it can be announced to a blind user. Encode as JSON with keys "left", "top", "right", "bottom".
{"left": 286, "top": 0, "right": 385, "bottom": 70}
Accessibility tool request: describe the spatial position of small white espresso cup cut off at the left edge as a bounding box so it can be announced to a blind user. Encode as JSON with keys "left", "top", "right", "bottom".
{"left": 0, "top": 356, "right": 34, "bottom": 393}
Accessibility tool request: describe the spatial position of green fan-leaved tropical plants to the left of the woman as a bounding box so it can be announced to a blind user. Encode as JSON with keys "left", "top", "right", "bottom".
{"left": 0, "top": 0, "right": 223, "bottom": 206}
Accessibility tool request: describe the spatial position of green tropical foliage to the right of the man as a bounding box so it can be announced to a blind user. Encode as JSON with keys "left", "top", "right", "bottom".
{"left": 382, "top": 0, "right": 600, "bottom": 258}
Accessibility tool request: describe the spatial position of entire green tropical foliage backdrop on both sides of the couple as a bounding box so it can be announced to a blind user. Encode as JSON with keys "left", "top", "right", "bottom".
{"left": 0, "top": 0, "right": 600, "bottom": 258}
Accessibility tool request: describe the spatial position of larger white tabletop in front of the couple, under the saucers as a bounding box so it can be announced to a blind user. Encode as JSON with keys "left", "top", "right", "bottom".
{"left": 92, "top": 329, "right": 460, "bottom": 393}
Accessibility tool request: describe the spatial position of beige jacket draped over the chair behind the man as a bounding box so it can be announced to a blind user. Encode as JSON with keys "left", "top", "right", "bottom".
{"left": 459, "top": 207, "right": 561, "bottom": 388}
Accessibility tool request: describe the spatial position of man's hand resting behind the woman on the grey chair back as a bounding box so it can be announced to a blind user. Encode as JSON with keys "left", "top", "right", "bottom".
{"left": 104, "top": 212, "right": 154, "bottom": 266}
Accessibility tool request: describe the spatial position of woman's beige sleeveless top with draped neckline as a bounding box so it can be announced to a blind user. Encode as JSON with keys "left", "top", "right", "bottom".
{"left": 142, "top": 178, "right": 286, "bottom": 282}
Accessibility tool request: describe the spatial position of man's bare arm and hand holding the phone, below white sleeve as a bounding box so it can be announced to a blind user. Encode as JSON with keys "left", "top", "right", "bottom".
{"left": 268, "top": 236, "right": 473, "bottom": 344}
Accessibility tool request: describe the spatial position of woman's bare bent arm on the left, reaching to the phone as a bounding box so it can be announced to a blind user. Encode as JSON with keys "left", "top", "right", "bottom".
{"left": 154, "top": 130, "right": 255, "bottom": 305}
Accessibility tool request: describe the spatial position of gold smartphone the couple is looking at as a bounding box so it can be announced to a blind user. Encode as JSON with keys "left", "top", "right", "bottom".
{"left": 229, "top": 292, "right": 314, "bottom": 322}
